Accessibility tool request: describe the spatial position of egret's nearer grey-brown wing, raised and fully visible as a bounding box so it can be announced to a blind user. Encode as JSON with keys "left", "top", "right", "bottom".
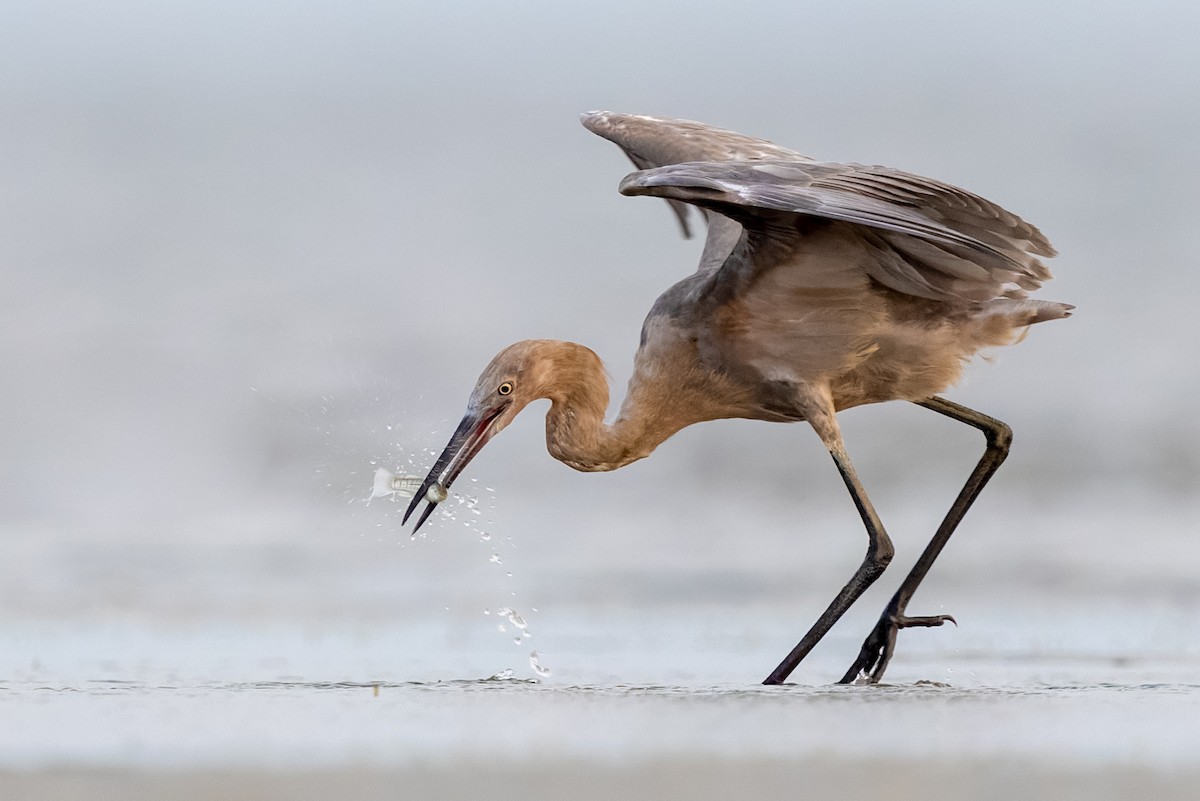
{"left": 620, "top": 161, "right": 1055, "bottom": 300}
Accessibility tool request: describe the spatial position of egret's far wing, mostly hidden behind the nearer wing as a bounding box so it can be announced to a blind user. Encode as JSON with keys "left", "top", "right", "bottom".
{"left": 581, "top": 112, "right": 810, "bottom": 271}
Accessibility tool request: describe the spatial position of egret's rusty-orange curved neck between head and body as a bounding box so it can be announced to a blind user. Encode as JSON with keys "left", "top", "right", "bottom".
{"left": 546, "top": 345, "right": 679, "bottom": 472}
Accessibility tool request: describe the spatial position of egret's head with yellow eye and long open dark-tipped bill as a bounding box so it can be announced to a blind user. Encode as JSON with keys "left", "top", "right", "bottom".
{"left": 404, "top": 339, "right": 602, "bottom": 531}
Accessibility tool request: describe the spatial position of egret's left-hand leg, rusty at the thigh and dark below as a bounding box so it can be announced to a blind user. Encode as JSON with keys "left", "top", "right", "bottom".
{"left": 762, "top": 412, "right": 895, "bottom": 685}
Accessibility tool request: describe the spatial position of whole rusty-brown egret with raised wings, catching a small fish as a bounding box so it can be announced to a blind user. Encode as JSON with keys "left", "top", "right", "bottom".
{"left": 404, "top": 112, "right": 1074, "bottom": 685}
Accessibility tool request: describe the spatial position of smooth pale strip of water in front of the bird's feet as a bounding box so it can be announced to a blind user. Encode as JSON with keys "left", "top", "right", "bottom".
{"left": 9, "top": 680, "right": 1200, "bottom": 770}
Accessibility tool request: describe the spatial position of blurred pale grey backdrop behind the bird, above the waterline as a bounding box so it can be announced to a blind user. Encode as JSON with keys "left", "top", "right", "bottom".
{"left": 0, "top": 0, "right": 1200, "bottom": 681}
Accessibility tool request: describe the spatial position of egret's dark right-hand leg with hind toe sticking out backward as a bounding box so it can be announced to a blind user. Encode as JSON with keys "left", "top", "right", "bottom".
{"left": 839, "top": 398, "right": 1013, "bottom": 685}
